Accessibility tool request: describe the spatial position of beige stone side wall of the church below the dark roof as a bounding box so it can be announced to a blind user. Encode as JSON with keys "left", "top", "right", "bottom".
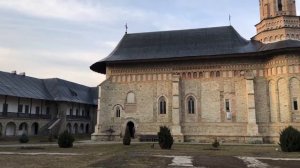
{"left": 93, "top": 55, "right": 300, "bottom": 142}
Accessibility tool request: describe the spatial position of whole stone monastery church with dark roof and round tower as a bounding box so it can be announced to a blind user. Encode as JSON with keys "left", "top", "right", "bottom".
{"left": 90, "top": 0, "right": 300, "bottom": 143}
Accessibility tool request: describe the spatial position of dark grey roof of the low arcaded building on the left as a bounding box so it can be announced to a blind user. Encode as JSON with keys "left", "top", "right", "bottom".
{"left": 0, "top": 71, "right": 97, "bottom": 105}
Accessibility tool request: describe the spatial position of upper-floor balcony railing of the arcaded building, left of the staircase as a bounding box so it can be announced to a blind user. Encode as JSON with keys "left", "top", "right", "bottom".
{"left": 0, "top": 112, "right": 51, "bottom": 119}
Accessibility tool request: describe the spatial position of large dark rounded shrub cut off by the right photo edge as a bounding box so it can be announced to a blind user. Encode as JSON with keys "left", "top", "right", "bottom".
{"left": 279, "top": 126, "right": 300, "bottom": 152}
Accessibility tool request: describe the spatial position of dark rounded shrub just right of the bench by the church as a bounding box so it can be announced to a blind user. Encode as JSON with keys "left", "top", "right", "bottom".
{"left": 157, "top": 126, "right": 174, "bottom": 149}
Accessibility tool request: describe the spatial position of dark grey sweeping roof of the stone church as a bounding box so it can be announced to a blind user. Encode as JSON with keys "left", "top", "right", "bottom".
{"left": 90, "top": 26, "right": 300, "bottom": 73}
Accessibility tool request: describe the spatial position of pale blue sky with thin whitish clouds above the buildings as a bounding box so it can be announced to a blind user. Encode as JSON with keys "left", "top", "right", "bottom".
{"left": 0, "top": 0, "right": 300, "bottom": 86}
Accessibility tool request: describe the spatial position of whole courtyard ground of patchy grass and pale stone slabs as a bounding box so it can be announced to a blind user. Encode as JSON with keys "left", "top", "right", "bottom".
{"left": 0, "top": 141, "right": 300, "bottom": 168}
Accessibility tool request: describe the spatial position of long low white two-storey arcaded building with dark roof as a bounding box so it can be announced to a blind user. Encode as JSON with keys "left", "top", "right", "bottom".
{"left": 0, "top": 72, "right": 97, "bottom": 136}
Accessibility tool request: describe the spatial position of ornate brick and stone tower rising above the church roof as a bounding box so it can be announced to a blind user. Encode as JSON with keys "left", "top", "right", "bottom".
{"left": 254, "top": 0, "right": 300, "bottom": 43}
